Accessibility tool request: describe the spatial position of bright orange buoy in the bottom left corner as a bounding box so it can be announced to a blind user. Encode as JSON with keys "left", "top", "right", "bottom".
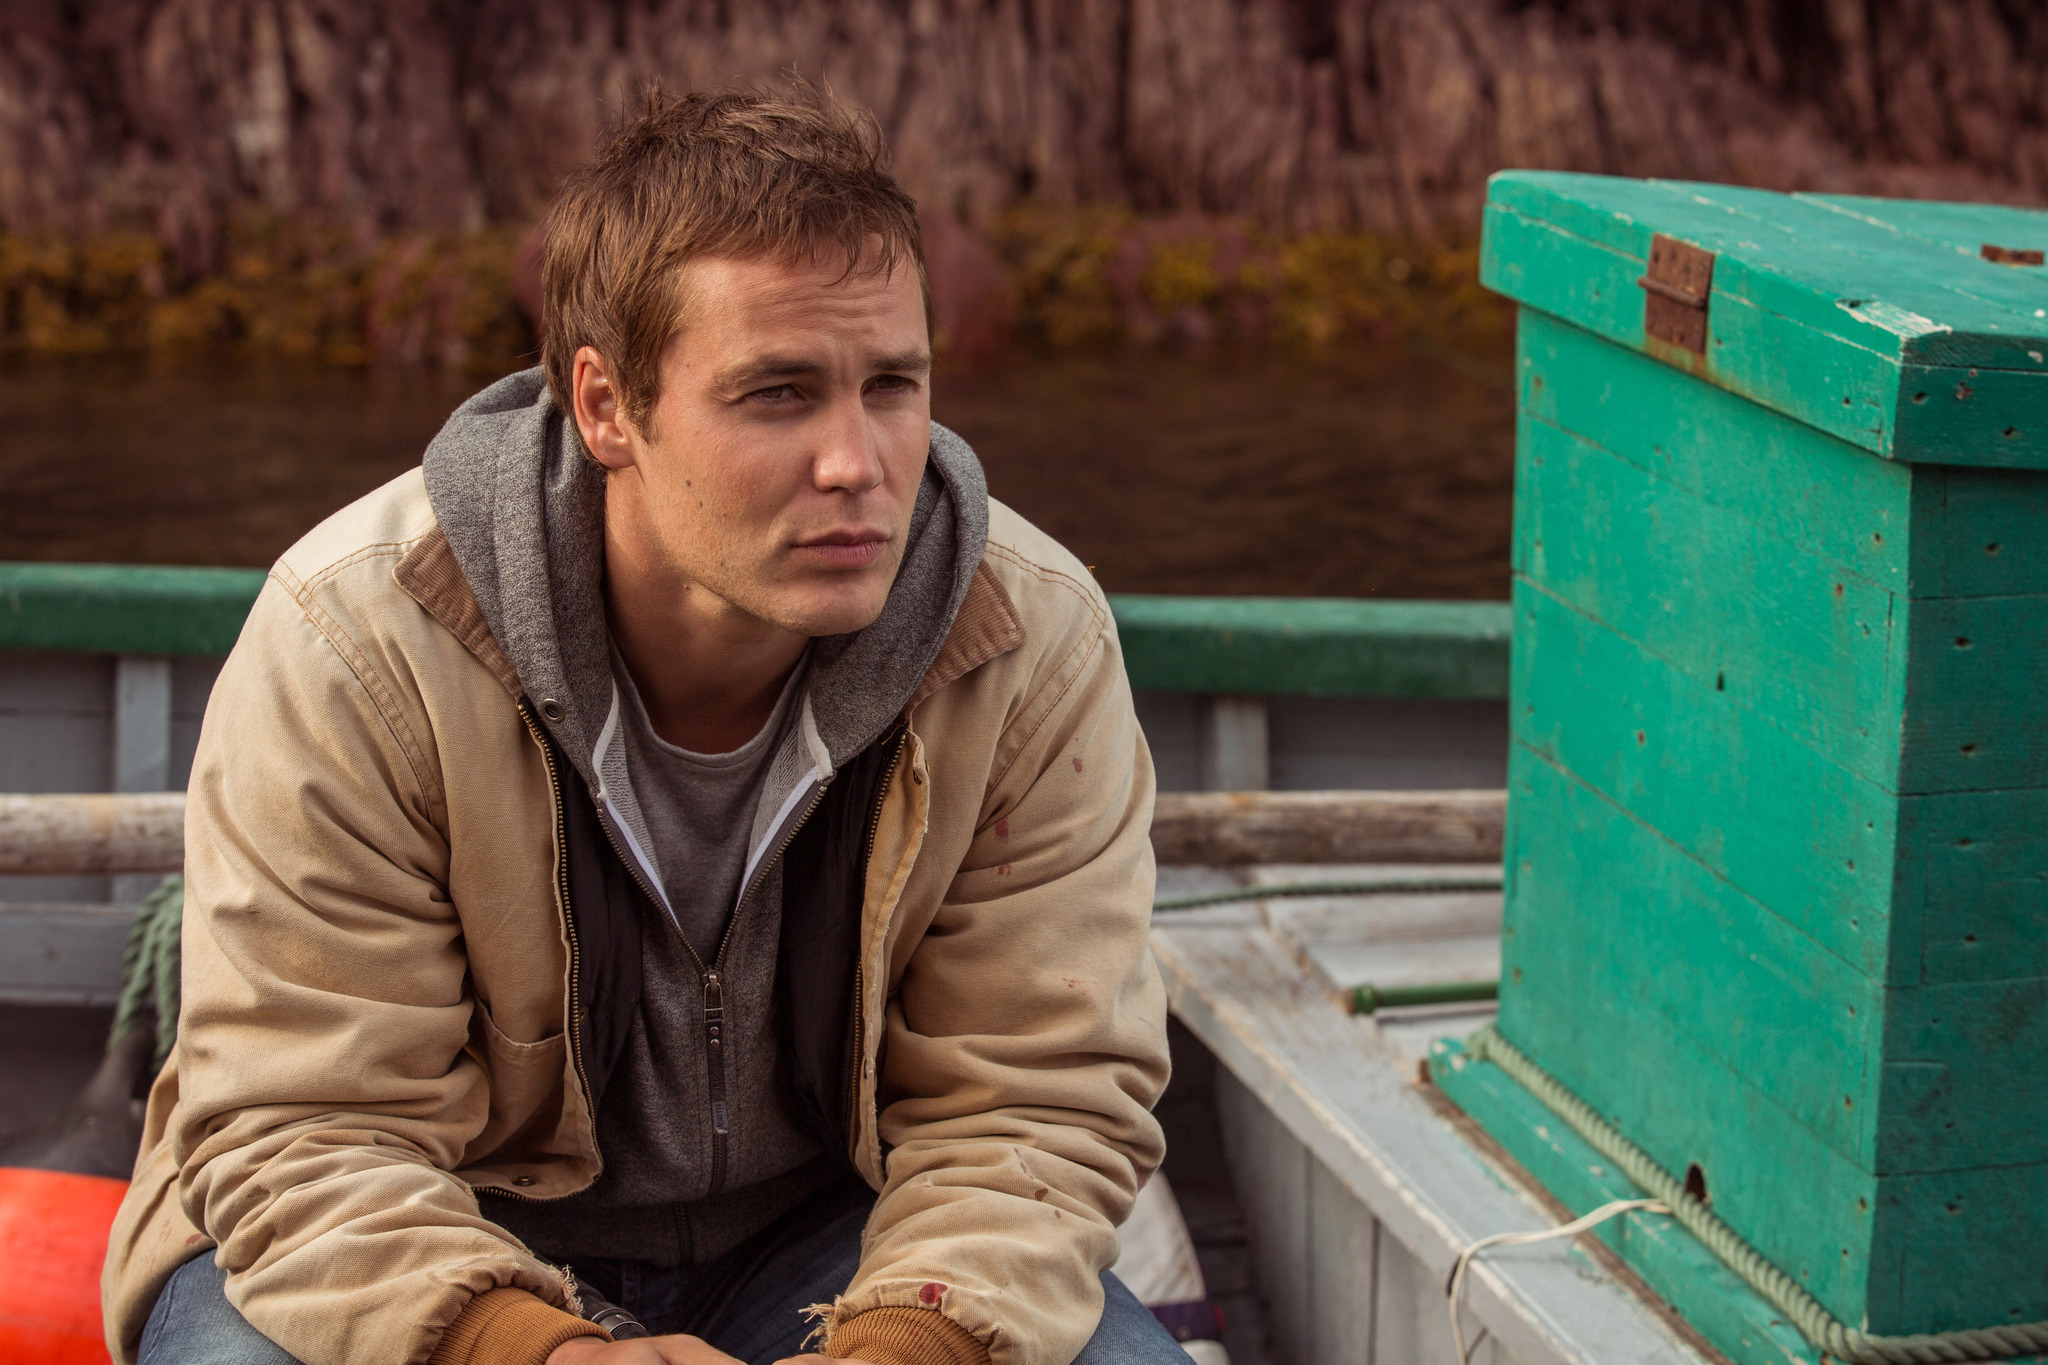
{"left": 0, "top": 1166, "right": 127, "bottom": 1365}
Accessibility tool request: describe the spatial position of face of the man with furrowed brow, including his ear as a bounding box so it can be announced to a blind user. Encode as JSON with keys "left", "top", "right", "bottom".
{"left": 578, "top": 256, "right": 932, "bottom": 636}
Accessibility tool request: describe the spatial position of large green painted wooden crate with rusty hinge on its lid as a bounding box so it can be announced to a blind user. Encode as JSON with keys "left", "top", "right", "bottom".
{"left": 1446, "top": 172, "right": 2048, "bottom": 1359}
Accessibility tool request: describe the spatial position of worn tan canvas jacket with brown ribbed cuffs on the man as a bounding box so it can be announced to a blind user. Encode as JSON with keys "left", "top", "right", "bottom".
{"left": 104, "top": 471, "right": 1167, "bottom": 1365}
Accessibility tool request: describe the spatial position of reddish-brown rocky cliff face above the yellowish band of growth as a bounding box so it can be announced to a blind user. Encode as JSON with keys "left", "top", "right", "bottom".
{"left": 0, "top": 0, "right": 2048, "bottom": 268}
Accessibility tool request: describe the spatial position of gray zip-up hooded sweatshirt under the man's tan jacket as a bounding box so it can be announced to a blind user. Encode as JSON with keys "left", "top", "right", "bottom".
{"left": 424, "top": 370, "right": 989, "bottom": 1265}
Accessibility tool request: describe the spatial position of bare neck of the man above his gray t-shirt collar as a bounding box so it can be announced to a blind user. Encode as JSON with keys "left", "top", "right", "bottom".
{"left": 604, "top": 518, "right": 809, "bottom": 753}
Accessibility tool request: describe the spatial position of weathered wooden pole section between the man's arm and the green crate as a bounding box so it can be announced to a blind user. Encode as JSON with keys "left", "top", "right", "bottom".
{"left": 1153, "top": 792, "right": 1507, "bottom": 866}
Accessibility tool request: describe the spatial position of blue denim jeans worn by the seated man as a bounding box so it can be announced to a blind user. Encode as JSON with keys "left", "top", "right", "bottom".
{"left": 139, "top": 1189, "right": 1188, "bottom": 1365}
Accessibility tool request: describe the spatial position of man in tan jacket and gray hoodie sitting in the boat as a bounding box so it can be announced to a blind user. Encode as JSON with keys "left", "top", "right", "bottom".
{"left": 106, "top": 94, "right": 1184, "bottom": 1365}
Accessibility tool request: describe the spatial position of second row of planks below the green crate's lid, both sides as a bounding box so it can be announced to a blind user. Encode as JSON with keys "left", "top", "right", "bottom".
{"left": 1516, "top": 411, "right": 2048, "bottom": 792}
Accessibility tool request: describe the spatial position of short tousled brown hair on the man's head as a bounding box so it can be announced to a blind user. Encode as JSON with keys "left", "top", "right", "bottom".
{"left": 541, "top": 80, "right": 930, "bottom": 428}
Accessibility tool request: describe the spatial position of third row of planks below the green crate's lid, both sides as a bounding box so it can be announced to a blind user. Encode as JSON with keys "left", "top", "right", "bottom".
{"left": 1516, "top": 548, "right": 2048, "bottom": 984}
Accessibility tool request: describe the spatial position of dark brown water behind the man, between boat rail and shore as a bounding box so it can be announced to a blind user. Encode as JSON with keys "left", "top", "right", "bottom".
{"left": 0, "top": 346, "right": 1513, "bottom": 598}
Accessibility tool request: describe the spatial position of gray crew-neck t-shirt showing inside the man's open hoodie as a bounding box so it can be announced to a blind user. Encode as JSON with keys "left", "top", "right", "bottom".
{"left": 612, "top": 649, "right": 805, "bottom": 966}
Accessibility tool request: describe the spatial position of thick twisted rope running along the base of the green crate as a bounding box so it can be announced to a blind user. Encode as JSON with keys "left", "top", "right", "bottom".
{"left": 1464, "top": 1025, "right": 2048, "bottom": 1365}
